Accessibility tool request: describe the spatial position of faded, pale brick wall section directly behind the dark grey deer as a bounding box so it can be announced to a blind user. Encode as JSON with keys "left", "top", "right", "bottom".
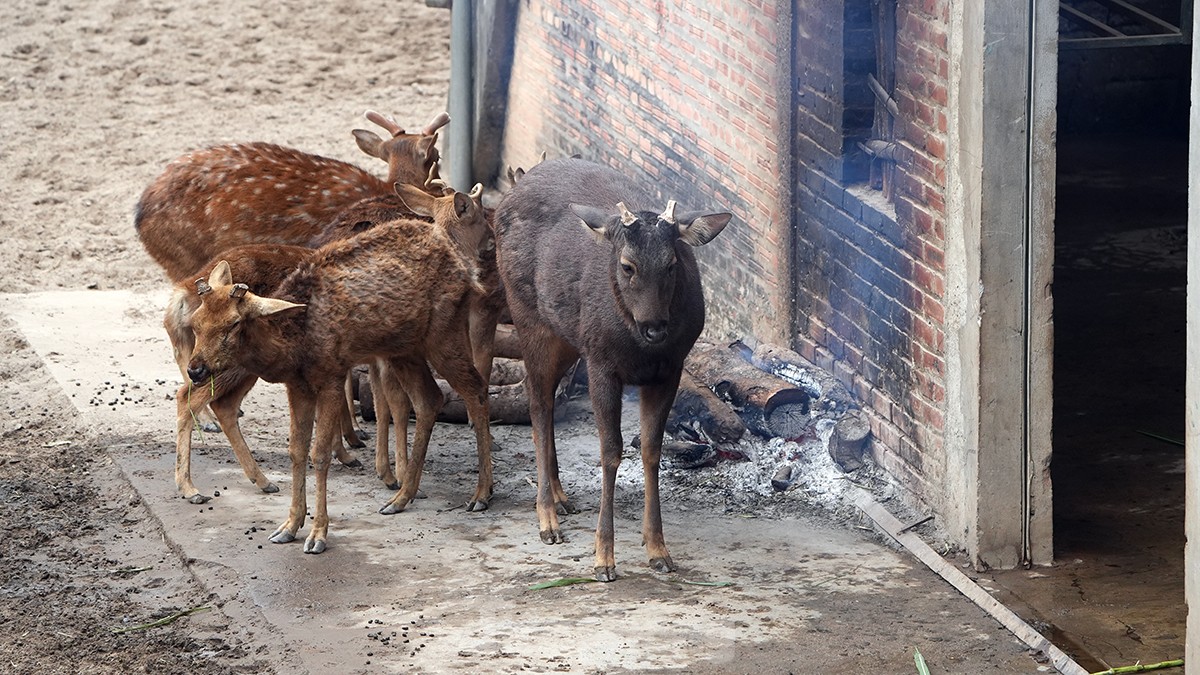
{"left": 502, "top": 0, "right": 791, "bottom": 341}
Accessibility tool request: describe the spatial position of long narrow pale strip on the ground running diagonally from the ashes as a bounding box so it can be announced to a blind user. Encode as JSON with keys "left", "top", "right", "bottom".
{"left": 854, "top": 489, "right": 1088, "bottom": 675}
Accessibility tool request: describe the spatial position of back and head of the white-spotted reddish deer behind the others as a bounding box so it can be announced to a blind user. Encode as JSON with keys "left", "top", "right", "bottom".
{"left": 133, "top": 112, "right": 450, "bottom": 281}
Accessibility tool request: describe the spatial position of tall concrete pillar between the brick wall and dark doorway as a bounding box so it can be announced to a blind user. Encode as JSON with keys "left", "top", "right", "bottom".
{"left": 944, "top": 0, "right": 1057, "bottom": 568}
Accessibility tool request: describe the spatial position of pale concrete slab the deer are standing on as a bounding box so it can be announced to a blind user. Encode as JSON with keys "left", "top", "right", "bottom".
{"left": 0, "top": 291, "right": 1045, "bottom": 674}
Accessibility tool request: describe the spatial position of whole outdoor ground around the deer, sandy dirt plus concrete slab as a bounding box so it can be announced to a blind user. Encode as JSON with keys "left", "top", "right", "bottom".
{"left": 0, "top": 0, "right": 1046, "bottom": 674}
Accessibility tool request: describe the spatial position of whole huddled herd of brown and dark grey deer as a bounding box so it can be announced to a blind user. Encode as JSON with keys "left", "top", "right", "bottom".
{"left": 134, "top": 112, "right": 731, "bottom": 581}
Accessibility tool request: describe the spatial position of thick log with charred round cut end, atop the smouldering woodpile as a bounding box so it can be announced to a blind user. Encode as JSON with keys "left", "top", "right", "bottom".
{"left": 684, "top": 342, "right": 814, "bottom": 440}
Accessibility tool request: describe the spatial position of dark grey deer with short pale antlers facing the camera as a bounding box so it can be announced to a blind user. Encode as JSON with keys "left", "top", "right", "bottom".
{"left": 496, "top": 159, "right": 731, "bottom": 581}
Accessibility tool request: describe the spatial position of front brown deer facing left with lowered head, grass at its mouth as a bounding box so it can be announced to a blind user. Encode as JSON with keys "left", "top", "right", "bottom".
{"left": 188, "top": 184, "right": 492, "bottom": 554}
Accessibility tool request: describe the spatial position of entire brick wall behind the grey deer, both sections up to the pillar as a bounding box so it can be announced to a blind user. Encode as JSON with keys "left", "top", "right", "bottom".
{"left": 504, "top": 0, "right": 949, "bottom": 502}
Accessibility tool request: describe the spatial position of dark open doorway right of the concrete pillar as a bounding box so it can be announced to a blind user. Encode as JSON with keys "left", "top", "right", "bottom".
{"left": 997, "top": 11, "right": 1190, "bottom": 671}
